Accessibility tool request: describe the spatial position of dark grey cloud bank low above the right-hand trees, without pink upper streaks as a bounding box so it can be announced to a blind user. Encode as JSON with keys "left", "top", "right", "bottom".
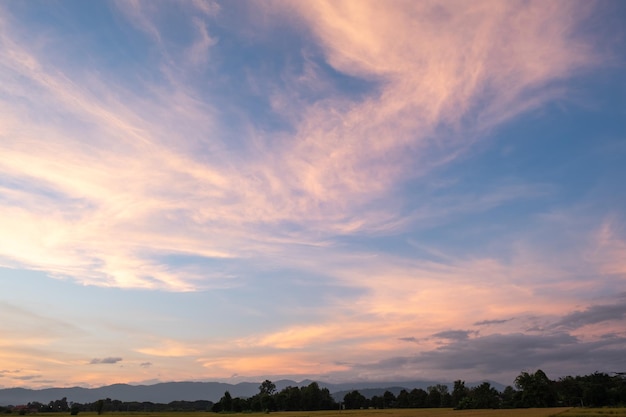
{"left": 354, "top": 332, "right": 626, "bottom": 383}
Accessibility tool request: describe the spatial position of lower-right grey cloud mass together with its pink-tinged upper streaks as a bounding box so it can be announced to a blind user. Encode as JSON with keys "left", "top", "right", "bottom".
{"left": 332, "top": 295, "right": 626, "bottom": 384}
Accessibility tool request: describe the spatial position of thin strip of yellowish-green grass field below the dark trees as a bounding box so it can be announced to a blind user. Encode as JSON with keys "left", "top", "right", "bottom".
{"left": 46, "top": 408, "right": 626, "bottom": 417}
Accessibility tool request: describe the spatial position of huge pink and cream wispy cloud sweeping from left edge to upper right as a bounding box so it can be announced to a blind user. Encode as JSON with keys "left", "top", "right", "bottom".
{"left": 0, "top": 2, "right": 608, "bottom": 290}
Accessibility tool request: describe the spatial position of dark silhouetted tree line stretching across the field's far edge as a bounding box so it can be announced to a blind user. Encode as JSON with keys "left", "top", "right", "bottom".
{"left": 0, "top": 370, "right": 626, "bottom": 415}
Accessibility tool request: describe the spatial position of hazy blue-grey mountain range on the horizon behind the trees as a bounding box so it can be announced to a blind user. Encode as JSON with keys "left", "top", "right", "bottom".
{"left": 0, "top": 379, "right": 504, "bottom": 406}
